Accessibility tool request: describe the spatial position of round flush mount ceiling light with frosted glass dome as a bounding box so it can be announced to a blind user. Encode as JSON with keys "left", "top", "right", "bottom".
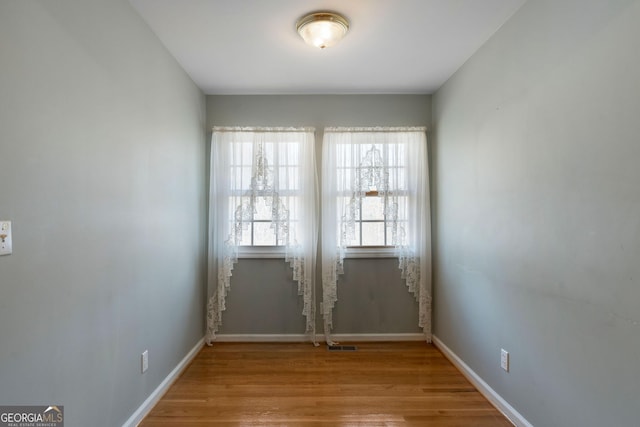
{"left": 296, "top": 12, "right": 349, "bottom": 49}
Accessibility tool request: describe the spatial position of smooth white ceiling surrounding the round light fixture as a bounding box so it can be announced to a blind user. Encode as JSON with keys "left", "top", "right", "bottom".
{"left": 130, "top": 0, "right": 526, "bottom": 94}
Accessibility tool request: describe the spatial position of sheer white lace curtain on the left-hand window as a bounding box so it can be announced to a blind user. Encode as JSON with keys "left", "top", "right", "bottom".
{"left": 206, "top": 127, "right": 318, "bottom": 344}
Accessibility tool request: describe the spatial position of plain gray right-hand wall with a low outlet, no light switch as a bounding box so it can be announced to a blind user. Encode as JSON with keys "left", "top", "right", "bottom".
{"left": 432, "top": 0, "right": 640, "bottom": 427}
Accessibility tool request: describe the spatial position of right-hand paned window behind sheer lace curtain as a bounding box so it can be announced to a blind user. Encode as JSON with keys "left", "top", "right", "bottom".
{"left": 322, "top": 128, "right": 428, "bottom": 254}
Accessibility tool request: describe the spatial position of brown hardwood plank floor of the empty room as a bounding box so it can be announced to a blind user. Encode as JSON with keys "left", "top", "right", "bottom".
{"left": 140, "top": 342, "right": 512, "bottom": 427}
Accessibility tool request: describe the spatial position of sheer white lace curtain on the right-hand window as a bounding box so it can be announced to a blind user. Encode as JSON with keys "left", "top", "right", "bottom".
{"left": 321, "top": 127, "right": 431, "bottom": 342}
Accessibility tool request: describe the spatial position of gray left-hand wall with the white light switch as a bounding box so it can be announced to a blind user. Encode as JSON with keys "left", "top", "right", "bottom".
{"left": 0, "top": 0, "right": 206, "bottom": 427}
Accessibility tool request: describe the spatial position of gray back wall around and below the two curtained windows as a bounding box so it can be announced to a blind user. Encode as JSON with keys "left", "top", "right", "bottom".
{"left": 207, "top": 95, "right": 431, "bottom": 334}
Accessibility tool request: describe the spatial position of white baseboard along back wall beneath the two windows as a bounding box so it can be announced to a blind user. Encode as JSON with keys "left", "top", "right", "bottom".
{"left": 214, "top": 332, "right": 425, "bottom": 343}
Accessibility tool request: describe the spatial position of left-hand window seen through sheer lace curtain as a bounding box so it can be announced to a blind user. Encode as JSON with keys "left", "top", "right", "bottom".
{"left": 212, "top": 128, "right": 316, "bottom": 254}
